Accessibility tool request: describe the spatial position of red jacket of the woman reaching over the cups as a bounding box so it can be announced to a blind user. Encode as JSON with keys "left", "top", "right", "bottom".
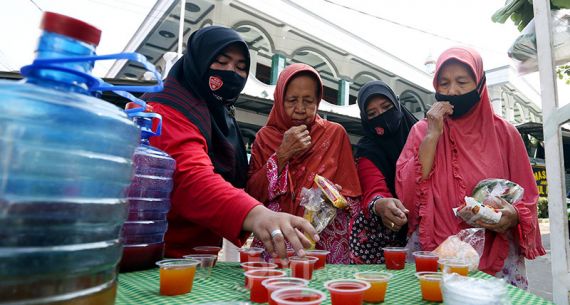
{"left": 149, "top": 102, "right": 260, "bottom": 257}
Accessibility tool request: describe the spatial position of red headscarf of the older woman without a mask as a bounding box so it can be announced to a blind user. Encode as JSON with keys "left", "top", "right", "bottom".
{"left": 248, "top": 64, "right": 361, "bottom": 216}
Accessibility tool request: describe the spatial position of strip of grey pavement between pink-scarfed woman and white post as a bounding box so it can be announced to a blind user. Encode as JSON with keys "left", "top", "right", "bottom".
{"left": 526, "top": 223, "right": 552, "bottom": 301}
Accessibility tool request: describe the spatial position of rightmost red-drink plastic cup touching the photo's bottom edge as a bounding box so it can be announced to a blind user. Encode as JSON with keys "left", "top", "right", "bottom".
{"left": 324, "top": 279, "right": 372, "bottom": 305}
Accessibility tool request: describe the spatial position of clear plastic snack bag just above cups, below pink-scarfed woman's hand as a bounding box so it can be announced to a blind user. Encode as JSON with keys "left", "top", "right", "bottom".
{"left": 433, "top": 228, "right": 485, "bottom": 271}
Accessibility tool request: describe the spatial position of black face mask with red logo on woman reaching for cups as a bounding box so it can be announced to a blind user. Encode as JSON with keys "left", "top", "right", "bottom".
{"left": 208, "top": 69, "right": 246, "bottom": 105}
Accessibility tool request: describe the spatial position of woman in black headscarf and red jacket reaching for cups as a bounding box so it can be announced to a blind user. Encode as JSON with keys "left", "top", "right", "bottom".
{"left": 143, "top": 26, "right": 318, "bottom": 257}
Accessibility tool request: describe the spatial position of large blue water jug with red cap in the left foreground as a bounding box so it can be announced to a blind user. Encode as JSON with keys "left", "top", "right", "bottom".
{"left": 0, "top": 13, "right": 162, "bottom": 304}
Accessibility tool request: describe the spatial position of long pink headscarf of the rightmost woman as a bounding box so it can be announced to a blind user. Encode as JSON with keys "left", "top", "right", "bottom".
{"left": 397, "top": 47, "right": 544, "bottom": 274}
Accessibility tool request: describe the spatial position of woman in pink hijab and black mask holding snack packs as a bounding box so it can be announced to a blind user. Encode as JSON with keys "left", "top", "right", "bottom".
{"left": 396, "top": 47, "right": 545, "bottom": 289}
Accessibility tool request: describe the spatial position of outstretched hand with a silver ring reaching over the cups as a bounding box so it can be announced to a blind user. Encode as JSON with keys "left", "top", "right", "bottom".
{"left": 242, "top": 205, "right": 319, "bottom": 259}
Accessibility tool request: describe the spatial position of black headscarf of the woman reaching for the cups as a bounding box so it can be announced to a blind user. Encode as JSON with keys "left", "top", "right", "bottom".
{"left": 144, "top": 26, "right": 250, "bottom": 188}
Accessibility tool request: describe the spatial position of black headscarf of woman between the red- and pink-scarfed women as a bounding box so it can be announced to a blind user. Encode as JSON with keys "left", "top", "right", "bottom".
{"left": 356, "top": 80, "right": 418, "bottom": 196}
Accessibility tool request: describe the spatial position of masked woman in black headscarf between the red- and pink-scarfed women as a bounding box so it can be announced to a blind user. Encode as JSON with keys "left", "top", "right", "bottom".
{"left": 350, "top": 81, "right": 417, "bottom": 264}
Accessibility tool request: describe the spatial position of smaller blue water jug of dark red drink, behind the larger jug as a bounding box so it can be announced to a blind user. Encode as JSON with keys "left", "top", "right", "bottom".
{"left": 120, "top": 103, "right": 176, "bottom": 271}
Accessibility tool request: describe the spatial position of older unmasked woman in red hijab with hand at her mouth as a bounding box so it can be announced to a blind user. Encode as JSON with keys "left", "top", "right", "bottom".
{"left": 246, "top": 64, "right": 361, "bottom": 264}
